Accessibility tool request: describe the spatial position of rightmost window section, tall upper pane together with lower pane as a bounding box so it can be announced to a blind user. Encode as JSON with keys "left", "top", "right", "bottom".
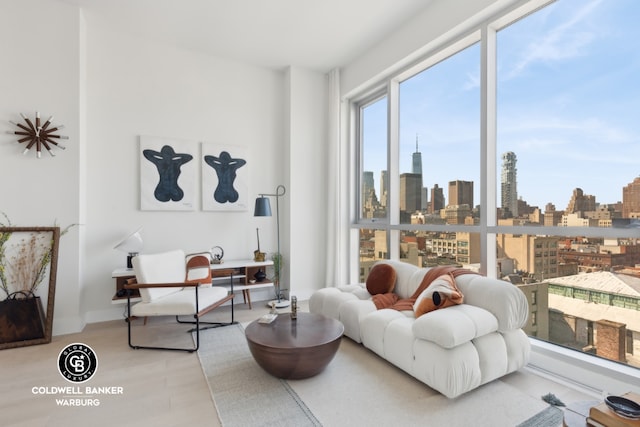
{"left": 496, "top": 0, "right": 640, "bottom": 372}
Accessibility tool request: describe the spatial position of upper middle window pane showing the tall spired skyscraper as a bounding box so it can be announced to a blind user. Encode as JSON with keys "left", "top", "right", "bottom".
{"left": 397, "top": 44, "right": 480, "bottom": 224}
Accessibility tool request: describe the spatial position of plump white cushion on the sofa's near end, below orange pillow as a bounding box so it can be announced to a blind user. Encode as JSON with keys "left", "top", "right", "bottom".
{"left": 412, "top": 304, "right": 498, "bottom": 348}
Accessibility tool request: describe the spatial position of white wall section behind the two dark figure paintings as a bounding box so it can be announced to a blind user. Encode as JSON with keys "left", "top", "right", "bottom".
{"left": 83, "top": 10, "right": 284, "bottom": 321}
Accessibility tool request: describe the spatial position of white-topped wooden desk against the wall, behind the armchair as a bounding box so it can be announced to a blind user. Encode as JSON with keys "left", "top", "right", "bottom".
{"left": 111, "top": 259, "right": 273, "bottom": 308}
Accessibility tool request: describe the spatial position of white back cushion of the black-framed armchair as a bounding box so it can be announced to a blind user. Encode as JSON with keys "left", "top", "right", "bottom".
{"left": 131, "top": 249, "right": 187, "bottom": 302}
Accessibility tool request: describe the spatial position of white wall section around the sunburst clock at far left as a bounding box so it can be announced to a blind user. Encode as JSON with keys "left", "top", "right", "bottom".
{"left": 0, "top": 0, "right": 84, "bottom": 333}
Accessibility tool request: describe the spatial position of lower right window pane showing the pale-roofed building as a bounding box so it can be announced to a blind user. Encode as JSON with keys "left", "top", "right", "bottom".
{"left": 497, "top": 234, "right": 640, "bottom": 367}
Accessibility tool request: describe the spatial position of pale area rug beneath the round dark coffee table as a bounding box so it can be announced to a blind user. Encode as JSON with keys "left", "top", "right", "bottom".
{"left": 198, "top": 326, "right": 562, "bottom": 427}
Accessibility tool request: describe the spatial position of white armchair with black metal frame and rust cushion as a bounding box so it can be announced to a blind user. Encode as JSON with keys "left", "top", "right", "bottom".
{"left": 125, "top": 250, "right": 236, "bottom": 352}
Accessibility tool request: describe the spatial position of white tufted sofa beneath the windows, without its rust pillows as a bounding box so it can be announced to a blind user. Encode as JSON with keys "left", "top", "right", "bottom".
{"left": 309, "top": 261, "right": 530, "bottom": 398}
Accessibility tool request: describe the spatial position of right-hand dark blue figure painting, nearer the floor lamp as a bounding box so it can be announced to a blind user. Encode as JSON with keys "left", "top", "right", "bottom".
{"left": 201, "top": 143, "right": 249, "bottom": 212}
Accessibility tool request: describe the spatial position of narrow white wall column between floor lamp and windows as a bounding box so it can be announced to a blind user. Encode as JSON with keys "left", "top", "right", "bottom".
{"left": 285, "top": 67, "right": 331, "bottom": 300}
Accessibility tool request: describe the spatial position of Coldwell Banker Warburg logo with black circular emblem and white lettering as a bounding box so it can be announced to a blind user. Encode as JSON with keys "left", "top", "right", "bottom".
{"left": 31, "top": 343, "right": 124, "bottom": 406}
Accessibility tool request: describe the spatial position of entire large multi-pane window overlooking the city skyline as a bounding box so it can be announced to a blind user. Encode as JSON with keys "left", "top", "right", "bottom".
{"left": 353, "top": 0, "right": 640, "bottom": 374}
